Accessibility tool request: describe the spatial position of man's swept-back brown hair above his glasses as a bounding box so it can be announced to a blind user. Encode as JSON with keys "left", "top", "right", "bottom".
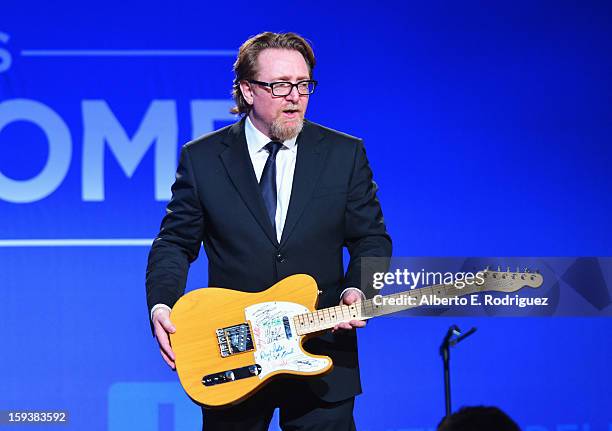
{"left": 231, "top": 31, "right": 315, "bottom": 114}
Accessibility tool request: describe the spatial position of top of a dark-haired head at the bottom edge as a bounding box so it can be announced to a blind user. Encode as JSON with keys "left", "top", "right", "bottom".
{"left": 437, "top": 406, "right": 521, "bottom": 431}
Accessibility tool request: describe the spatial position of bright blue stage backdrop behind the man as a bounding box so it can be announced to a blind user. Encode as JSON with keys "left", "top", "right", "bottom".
{"left": 0, "top": 0, "right": 612, "bottom": 431}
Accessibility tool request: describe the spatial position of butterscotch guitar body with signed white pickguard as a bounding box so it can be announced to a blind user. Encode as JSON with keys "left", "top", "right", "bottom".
{"left": 170, "top": 274, "right": 332, "bottom": 407}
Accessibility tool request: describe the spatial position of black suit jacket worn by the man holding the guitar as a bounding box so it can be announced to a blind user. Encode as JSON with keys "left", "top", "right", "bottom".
{"left": 146, "top": 118, "right": 391, "bottom": 402}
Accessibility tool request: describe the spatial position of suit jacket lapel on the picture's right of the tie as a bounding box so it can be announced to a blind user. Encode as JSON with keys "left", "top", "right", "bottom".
{"left": 280, "top": 120, "right": 326, "bottom": 250}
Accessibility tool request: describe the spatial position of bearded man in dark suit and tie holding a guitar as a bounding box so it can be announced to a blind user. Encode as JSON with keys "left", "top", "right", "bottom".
{"left": 147, "top": 32, "right": 391, "bottom": 430}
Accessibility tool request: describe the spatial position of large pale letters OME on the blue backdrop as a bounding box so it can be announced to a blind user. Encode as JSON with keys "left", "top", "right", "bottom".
{"left": 0, "top": 99, "right": 236, "bottom": 203}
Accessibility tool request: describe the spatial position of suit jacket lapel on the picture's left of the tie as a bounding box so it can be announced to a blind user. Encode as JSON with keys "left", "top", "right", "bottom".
{"left": 220, "top": 118, "right": 278, "bottom": 246}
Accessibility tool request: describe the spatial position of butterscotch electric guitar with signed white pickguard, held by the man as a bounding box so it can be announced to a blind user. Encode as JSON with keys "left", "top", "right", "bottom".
{"left": 170, "top": 269, "right": 543, "bottom": 408}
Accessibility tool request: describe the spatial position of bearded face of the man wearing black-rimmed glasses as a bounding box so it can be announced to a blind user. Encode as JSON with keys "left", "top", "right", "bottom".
{"left": 241, "top": 48, "right": 310, "bottom": 141}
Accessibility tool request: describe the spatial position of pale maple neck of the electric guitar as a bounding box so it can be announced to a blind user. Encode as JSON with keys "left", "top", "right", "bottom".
{"left": 294, "top": 284, "right": 483, "bottom": 335}
